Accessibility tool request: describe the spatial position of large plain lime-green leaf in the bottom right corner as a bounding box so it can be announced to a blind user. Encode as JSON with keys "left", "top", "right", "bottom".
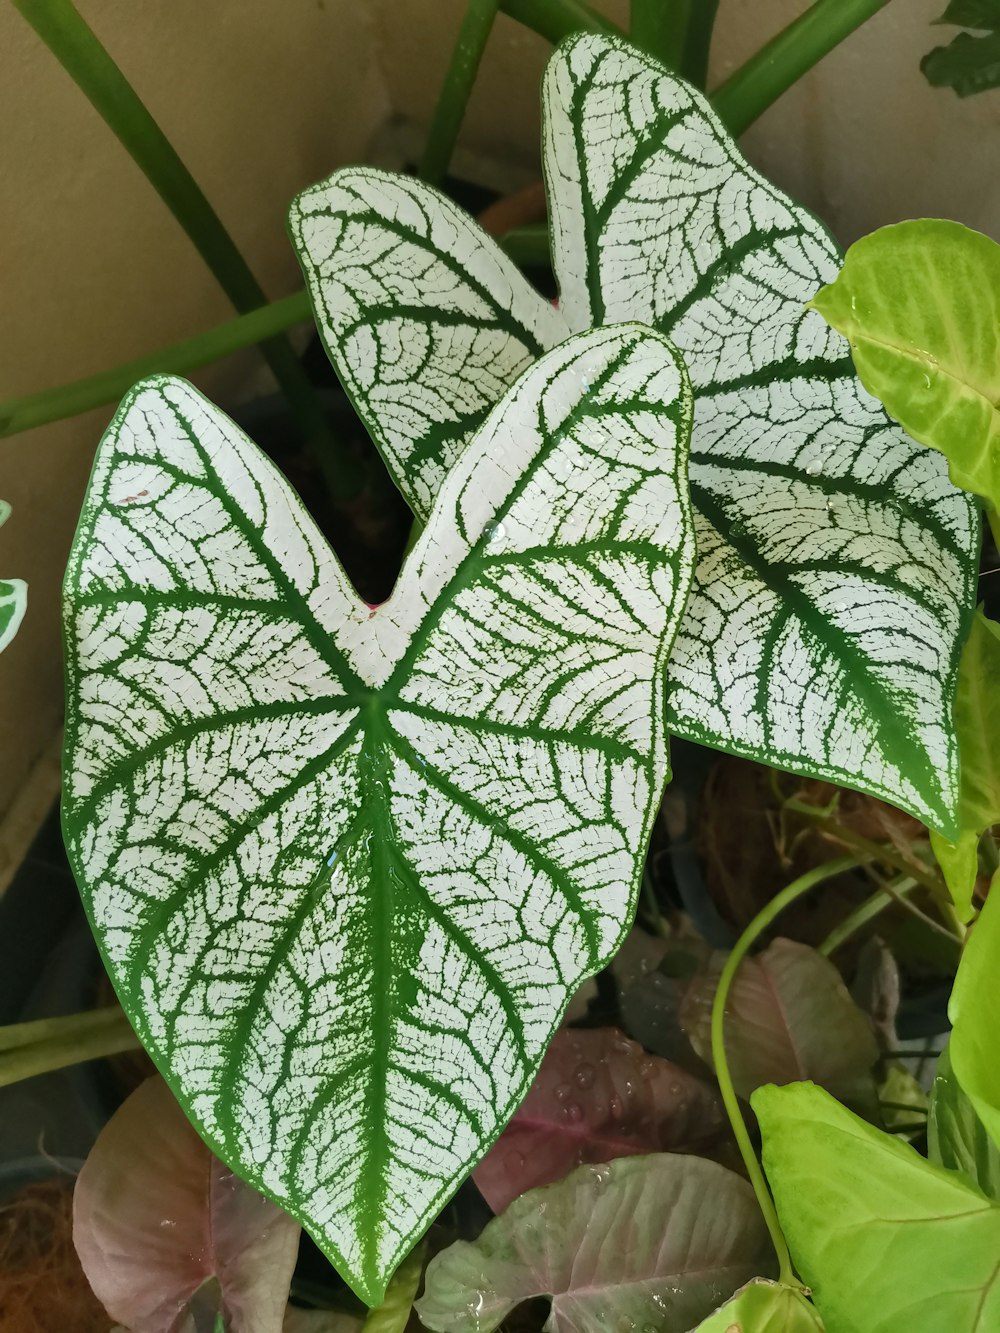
{"left": 752, "top": 1084, "right": 1000, "bottom": 1333}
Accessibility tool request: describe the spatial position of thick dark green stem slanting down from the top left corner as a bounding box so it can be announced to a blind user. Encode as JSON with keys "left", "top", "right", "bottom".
{"left": 13, "top": 0, "right": 361, "bottom": 500}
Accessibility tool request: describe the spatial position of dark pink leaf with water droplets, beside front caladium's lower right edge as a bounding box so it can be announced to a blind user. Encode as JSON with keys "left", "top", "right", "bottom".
{"left": 472, "top": 1028, "right": 725, "bottom": 1213}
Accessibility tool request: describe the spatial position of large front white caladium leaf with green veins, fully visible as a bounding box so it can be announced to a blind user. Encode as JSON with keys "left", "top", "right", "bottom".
{"left": 64, "top": 327, "right": 693, "bottom": 1304}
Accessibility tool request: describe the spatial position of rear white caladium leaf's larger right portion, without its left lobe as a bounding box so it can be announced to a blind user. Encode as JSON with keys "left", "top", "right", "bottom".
{"left": 544, "top": 36, "right": 979, "bottom": 832}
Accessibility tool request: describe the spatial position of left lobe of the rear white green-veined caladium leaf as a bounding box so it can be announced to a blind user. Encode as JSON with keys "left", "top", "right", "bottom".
{"left": 289, "top": 167, "right": 569, "bottom": 521}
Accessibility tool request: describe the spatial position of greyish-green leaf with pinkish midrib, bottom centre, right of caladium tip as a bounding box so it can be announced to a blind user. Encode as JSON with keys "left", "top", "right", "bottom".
{"left": 416, "top": 1153, "right": 767, "bottom": 1333}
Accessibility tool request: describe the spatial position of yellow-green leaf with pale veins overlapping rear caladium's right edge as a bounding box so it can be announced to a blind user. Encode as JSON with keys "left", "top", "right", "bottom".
{"left": 812, "top": 219, "right": 1000, "bottom": 509}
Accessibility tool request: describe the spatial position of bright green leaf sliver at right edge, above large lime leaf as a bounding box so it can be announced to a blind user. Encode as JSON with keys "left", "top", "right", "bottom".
{"left": 948, "top": 892, "right": 1000, "bottom": 1146}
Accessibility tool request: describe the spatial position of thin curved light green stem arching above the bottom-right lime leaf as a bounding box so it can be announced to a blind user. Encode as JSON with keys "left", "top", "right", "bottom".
{"left": 712, "top": 856, "right": 868, "bottom": 1286}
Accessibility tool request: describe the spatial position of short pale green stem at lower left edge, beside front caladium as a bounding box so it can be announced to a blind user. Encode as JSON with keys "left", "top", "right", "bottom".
{"left": 0, "top": 1005, "right": 140, "bottom": 1088}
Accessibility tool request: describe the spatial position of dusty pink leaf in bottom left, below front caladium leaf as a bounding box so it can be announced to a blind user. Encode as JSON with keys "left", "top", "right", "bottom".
{"left": 73, "top": 1078, "right": 299, "bottom": 1333}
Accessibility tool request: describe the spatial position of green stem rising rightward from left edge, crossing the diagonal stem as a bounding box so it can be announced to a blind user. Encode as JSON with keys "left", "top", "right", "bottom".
{"left": 0, "top": 292, "right": 312, "bottom": 439}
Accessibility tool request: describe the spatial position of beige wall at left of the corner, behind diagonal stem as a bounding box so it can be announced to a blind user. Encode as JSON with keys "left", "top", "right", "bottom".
{"left": 0, "top": 0, "right": 388, "bottom": 821}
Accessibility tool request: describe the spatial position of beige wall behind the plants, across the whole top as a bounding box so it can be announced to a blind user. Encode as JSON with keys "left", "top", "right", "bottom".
{"left": 0, "top": 0, "right": 1000, "bottom": 812}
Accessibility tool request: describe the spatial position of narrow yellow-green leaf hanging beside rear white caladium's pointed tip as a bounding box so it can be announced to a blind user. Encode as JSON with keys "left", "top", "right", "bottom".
{"left": 931, "top": 611, "right": 1000, "bottom": 921}
